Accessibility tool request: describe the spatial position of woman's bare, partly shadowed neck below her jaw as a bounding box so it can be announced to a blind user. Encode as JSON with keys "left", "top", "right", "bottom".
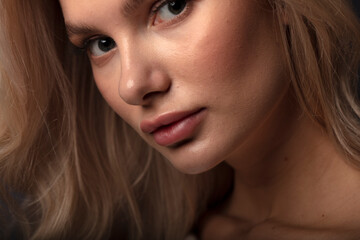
{"left": 224, "top": 91, "right": 360, "bottom": 227}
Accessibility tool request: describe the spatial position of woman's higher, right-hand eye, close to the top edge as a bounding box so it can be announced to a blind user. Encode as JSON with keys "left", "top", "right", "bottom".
{"left": 153, "top": 0, "right": 189, "bottom": 25}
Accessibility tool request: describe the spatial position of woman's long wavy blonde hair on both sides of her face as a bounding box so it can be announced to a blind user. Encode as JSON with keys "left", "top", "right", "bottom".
{"left": 0, "top": 0, "right": 360, "bottom": 240}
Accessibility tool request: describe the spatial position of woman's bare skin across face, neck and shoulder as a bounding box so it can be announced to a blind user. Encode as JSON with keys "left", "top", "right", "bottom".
{"left": 60, "top": 0, "right": 360, "bottom": 239}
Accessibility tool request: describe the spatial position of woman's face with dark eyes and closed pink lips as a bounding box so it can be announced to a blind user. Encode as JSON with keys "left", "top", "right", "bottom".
{"left": 60, "top": 0, "right": 288, "bottom": 173}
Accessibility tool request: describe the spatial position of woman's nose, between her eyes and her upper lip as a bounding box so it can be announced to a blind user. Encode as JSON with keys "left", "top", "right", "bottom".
{"left": 118, "top": 36, "right": 171, "bottom": 105}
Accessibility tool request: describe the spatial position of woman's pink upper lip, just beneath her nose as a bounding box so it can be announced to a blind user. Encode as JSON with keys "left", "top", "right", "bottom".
{"left": 140, "top": 109, "right": 202, "bottom": 133}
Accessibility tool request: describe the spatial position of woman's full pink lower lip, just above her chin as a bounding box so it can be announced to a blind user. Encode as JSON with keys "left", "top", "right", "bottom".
{"left": 152, "top": 109, "right": 205, "bottom": 146}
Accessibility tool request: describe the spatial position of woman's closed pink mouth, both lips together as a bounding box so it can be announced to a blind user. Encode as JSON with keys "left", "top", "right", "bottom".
{"left": 140, "top": 108, "right": 206, "bottom": 146}
